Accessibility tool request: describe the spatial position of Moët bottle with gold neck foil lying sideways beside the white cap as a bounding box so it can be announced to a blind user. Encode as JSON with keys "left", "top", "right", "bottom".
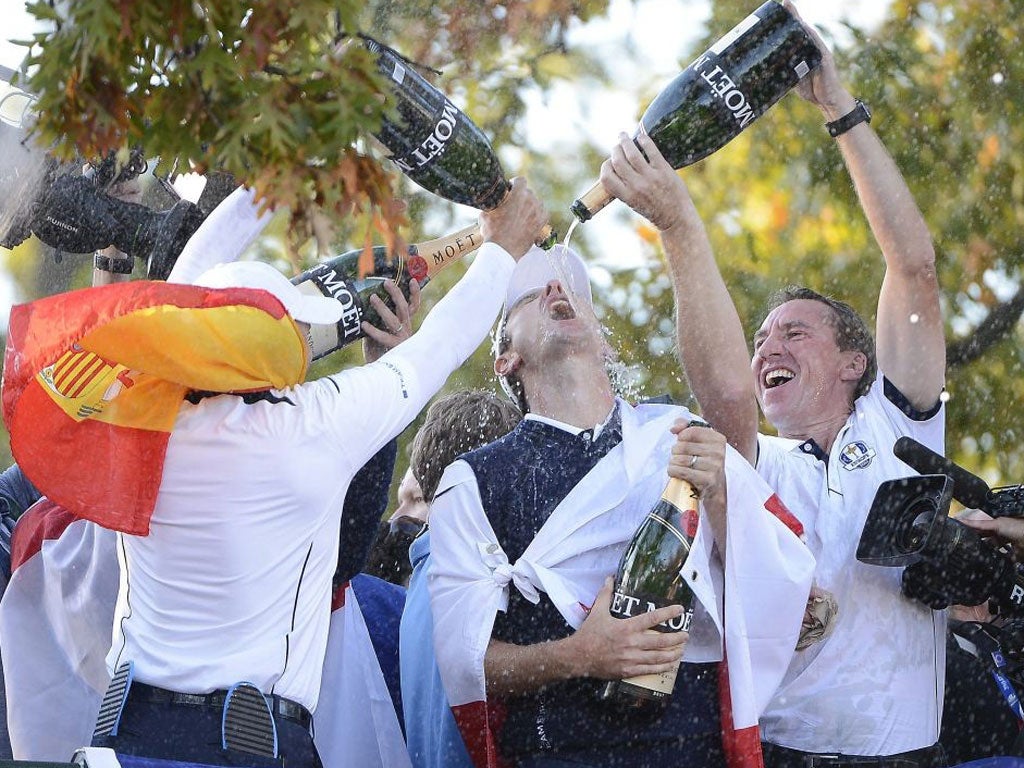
{"left": 292, "top": 225, "right": 483, "bottom": 360}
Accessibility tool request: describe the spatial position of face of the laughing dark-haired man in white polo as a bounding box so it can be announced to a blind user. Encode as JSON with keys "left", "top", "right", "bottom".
{"left": 751, "top": 299, "right": 865, "bottom": 437}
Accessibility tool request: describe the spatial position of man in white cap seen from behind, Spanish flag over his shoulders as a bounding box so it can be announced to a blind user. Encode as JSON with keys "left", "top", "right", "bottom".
{"left": 83, "top": 179, "right": 545, "bottom": 768}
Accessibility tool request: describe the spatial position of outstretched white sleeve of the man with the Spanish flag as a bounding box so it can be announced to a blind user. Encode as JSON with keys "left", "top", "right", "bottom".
{"left": 306, "top": 243, "right": 515, "bottom": 466}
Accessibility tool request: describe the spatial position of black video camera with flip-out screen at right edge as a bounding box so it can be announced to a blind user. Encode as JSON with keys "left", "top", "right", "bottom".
{"left": 857, "top": 437, "right": 1024, "bottom": 614}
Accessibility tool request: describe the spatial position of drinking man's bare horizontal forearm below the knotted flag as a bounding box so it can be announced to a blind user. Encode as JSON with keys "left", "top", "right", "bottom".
{"left": 483, "top": 636, "right": 583, "bottom": 696}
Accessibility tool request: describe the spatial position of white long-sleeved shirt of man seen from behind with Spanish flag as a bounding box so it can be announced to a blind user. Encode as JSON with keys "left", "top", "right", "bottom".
{"left": 108, "top": 243, "right": 514, "bottom": 710}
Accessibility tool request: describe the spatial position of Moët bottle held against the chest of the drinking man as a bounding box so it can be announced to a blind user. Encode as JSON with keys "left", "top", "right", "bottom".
{"left": 602, "top": 477, "right": 697, "bottom": 707}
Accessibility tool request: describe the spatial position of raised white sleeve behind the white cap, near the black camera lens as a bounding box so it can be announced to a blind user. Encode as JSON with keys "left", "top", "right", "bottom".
{"left": 167, "top": 186, "right": 273, "bottom": 285}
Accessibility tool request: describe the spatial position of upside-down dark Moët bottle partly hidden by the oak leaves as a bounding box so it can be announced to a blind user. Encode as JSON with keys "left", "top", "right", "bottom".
{"left": 362, "top": 37, "right": 554, "bottom": 245}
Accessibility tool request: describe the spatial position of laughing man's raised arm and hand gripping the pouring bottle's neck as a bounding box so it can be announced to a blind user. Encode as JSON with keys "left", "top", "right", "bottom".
{"left": 601, "top": 133, "right": 758, "bottom": 462}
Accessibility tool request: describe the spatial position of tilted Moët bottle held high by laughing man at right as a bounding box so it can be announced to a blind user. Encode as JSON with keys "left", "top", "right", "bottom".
{"left": 571, "top": 0, "right": 821, "bottom": 221}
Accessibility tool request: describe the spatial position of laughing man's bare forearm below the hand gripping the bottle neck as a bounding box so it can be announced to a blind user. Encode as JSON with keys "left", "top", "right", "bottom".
{"left": 662, "top": 210, "right": 758, "bottom": 462}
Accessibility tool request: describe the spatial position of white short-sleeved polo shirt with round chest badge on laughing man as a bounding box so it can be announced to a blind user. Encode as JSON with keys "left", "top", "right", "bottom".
{"left": 757, "top": 375, "right": 946, "bottom": 755}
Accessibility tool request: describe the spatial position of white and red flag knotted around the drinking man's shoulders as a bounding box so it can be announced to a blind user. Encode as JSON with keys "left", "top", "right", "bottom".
{"left": 429, "top": 399, "right": 814, "bottom": 768}
